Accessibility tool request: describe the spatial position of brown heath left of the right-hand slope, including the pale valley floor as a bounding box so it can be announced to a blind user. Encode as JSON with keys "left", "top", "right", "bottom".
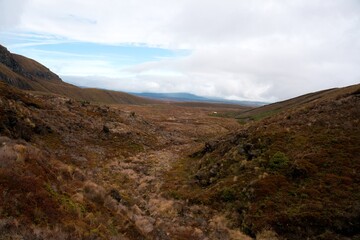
{"left": 0, "top": 86, "right": 253, "bottom": 239}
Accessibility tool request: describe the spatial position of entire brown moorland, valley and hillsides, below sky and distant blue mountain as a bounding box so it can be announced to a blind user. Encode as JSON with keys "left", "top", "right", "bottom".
{"left": 0, "top": 48, "right": 360, "bottom": 240}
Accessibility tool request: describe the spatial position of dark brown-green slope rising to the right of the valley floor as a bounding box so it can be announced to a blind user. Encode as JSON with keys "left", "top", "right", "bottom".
{"left": 164, "top": 85, "right": 360, "bottom": 239}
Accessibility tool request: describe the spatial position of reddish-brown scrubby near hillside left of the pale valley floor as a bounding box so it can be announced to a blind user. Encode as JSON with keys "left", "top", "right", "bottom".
{"left": 0, "top": 82, "right": 161, "bottom": 239}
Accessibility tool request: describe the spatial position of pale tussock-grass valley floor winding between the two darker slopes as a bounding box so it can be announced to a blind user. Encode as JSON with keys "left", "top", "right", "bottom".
{"left": 98, "top": 105, "right": 250, "bottom": 239}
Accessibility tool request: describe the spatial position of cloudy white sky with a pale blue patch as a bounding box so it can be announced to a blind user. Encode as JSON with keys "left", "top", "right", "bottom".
{"left": 0, "top": 0, "right": 360, "bottom": 102}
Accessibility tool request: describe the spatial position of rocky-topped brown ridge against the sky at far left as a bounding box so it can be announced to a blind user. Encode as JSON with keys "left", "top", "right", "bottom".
{"left": 0, "top": 45, "right": 156, "bottom": 104}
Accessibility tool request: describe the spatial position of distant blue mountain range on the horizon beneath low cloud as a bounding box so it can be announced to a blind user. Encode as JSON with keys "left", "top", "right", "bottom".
{"left": 130, "top": 92, "right": 268, "bottom": 106}
